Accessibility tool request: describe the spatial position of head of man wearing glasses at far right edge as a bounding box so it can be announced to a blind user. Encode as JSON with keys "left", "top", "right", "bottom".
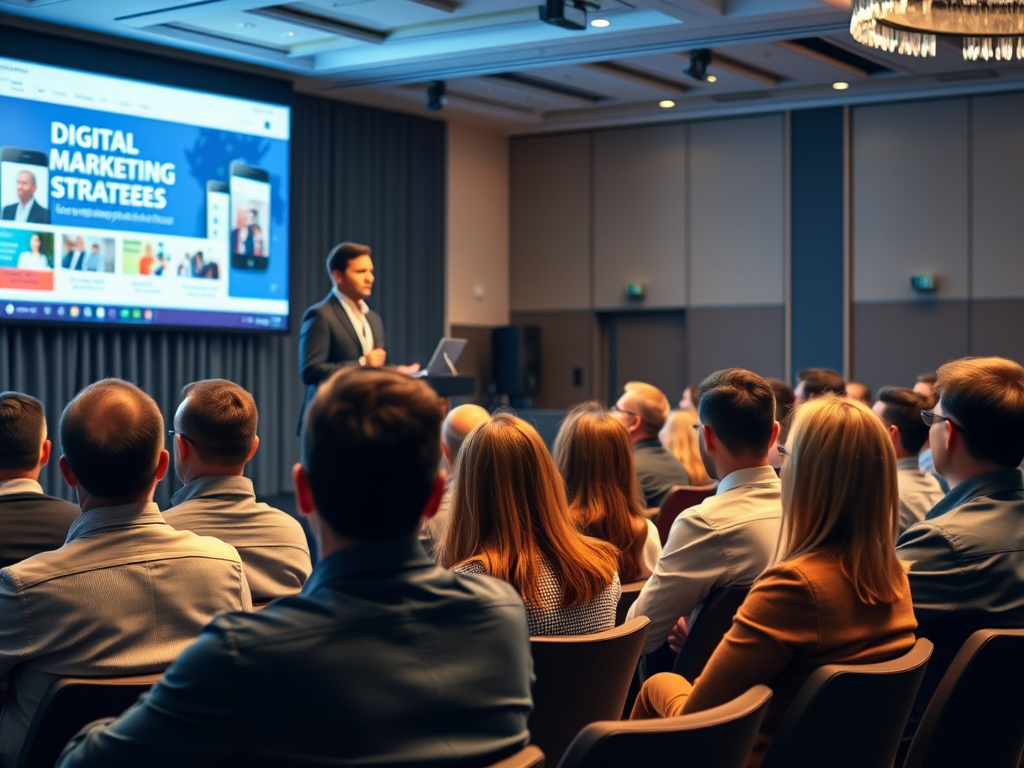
{"left": 925, "top": 357, "right": 1024, "bottom": 485}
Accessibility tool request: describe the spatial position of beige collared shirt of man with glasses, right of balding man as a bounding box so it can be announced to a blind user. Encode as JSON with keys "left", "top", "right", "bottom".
{"left": 164, "top": 475, "right": 313, "bottom": 605}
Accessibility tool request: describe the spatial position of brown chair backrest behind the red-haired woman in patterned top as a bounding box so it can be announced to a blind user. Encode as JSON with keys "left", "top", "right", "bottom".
{"left": 528, "top": 616, "right": 650, "bottom": 765}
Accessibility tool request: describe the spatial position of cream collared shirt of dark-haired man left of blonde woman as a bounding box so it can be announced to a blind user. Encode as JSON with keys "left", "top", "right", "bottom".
{"left": 627, "top": 467, "right": 782, "bottom": 653}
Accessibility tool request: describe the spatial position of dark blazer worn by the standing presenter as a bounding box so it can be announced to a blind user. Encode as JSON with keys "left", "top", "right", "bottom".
{"left": 298, "top": 291, "right": 387, "bottom": 434}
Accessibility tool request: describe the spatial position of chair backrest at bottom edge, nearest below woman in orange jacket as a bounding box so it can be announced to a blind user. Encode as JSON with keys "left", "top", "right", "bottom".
{"left": 559, "top": 685, "right": 771, "bottom": 768}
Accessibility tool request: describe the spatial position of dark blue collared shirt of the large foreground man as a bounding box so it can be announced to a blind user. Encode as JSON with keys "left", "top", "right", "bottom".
{"left": 59, "top": 538, "right": 532, "bottom": 768}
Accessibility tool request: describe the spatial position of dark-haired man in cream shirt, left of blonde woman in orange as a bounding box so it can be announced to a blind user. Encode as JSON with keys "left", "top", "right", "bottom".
{"left": 629, "top": 368, "right": 782, "bottom": 653}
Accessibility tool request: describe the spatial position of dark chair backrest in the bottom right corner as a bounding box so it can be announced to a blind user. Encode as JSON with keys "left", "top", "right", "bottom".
{"left": 905, "top": 630, "right": 1024, "bottom": 768}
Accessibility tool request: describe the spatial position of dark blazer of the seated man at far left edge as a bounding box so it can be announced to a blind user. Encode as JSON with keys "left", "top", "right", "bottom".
{"left": 0, "top": 492, "right": 82, "bottom": 568}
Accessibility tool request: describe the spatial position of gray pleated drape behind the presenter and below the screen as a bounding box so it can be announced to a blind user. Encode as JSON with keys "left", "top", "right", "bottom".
{"left": 0, "top": 95, "right": 445, "bottom": 507}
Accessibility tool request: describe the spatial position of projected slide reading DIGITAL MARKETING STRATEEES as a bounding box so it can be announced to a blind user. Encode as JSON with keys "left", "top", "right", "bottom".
{"left": 0, "top": 57, "right": 291, "bottom": 331}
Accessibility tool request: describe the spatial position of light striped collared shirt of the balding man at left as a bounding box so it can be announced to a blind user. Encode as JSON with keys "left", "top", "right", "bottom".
{"left": 0, "top": 502, "right": 252, "bottom": 768}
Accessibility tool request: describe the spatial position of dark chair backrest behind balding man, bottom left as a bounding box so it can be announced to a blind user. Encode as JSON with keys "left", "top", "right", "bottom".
{"left": 17, "top": 673, "right": 163, "bottom": 768}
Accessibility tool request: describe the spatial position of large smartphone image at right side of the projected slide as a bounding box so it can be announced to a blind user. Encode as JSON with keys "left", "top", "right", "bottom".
{"left": 229, "top": 162, "right": 270, "bottom": 269}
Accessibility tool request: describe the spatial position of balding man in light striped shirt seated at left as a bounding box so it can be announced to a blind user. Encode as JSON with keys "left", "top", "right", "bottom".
{"left": 0, "top": 379, "right": 252, "bottom": 768}
